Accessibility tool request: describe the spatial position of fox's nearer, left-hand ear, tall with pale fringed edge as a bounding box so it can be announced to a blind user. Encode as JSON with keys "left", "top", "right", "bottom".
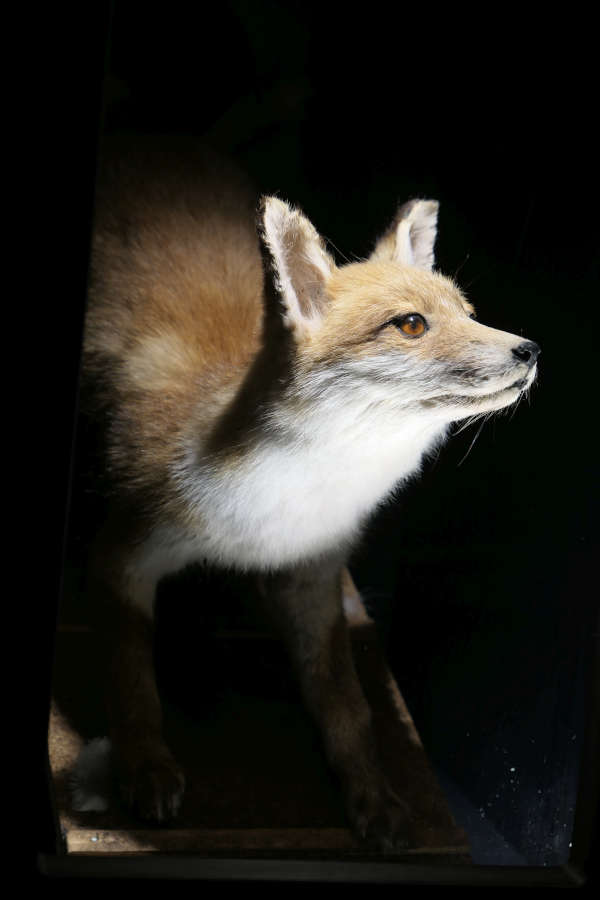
{"left": 259, "top": 197, "right": 335, "bottom": 335}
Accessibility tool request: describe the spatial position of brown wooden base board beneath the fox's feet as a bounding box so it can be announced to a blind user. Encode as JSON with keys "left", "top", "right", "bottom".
{"left": 49, "top": 568, "right": 470, "bottom": 864}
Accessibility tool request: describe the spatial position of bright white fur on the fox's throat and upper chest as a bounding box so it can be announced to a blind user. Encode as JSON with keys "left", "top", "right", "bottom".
{"left": 165, "top": 388, "right": 445, "bottom": 569}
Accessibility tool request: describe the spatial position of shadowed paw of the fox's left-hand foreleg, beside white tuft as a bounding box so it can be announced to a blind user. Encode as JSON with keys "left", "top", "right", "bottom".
{"left": 118, "top": 750, "right": 185, "bottom": 822}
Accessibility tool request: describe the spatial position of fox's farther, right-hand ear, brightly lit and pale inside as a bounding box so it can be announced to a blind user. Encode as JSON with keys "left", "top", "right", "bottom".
{"left": 370, "top": 200, "right": 439, "bottom": 270}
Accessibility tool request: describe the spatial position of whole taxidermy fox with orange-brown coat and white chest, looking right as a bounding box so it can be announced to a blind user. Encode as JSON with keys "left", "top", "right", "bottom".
{"left": 82, "top": 132, "right": 539, "bottom": 847}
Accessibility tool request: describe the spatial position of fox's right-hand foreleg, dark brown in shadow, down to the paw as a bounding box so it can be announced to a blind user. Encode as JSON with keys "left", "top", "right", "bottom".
{"left": 263, "top": 564, "right": 409, "bottom": 850}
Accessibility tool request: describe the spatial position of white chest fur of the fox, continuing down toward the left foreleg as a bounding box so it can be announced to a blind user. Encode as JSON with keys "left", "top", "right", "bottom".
{"left": 129, "top": 417, "right": 445, "bottom": 612}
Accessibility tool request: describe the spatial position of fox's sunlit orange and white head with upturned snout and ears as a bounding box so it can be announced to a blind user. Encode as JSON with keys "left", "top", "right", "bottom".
{"left": 259, "top": 197, "right": 540, "bottom": 424}
